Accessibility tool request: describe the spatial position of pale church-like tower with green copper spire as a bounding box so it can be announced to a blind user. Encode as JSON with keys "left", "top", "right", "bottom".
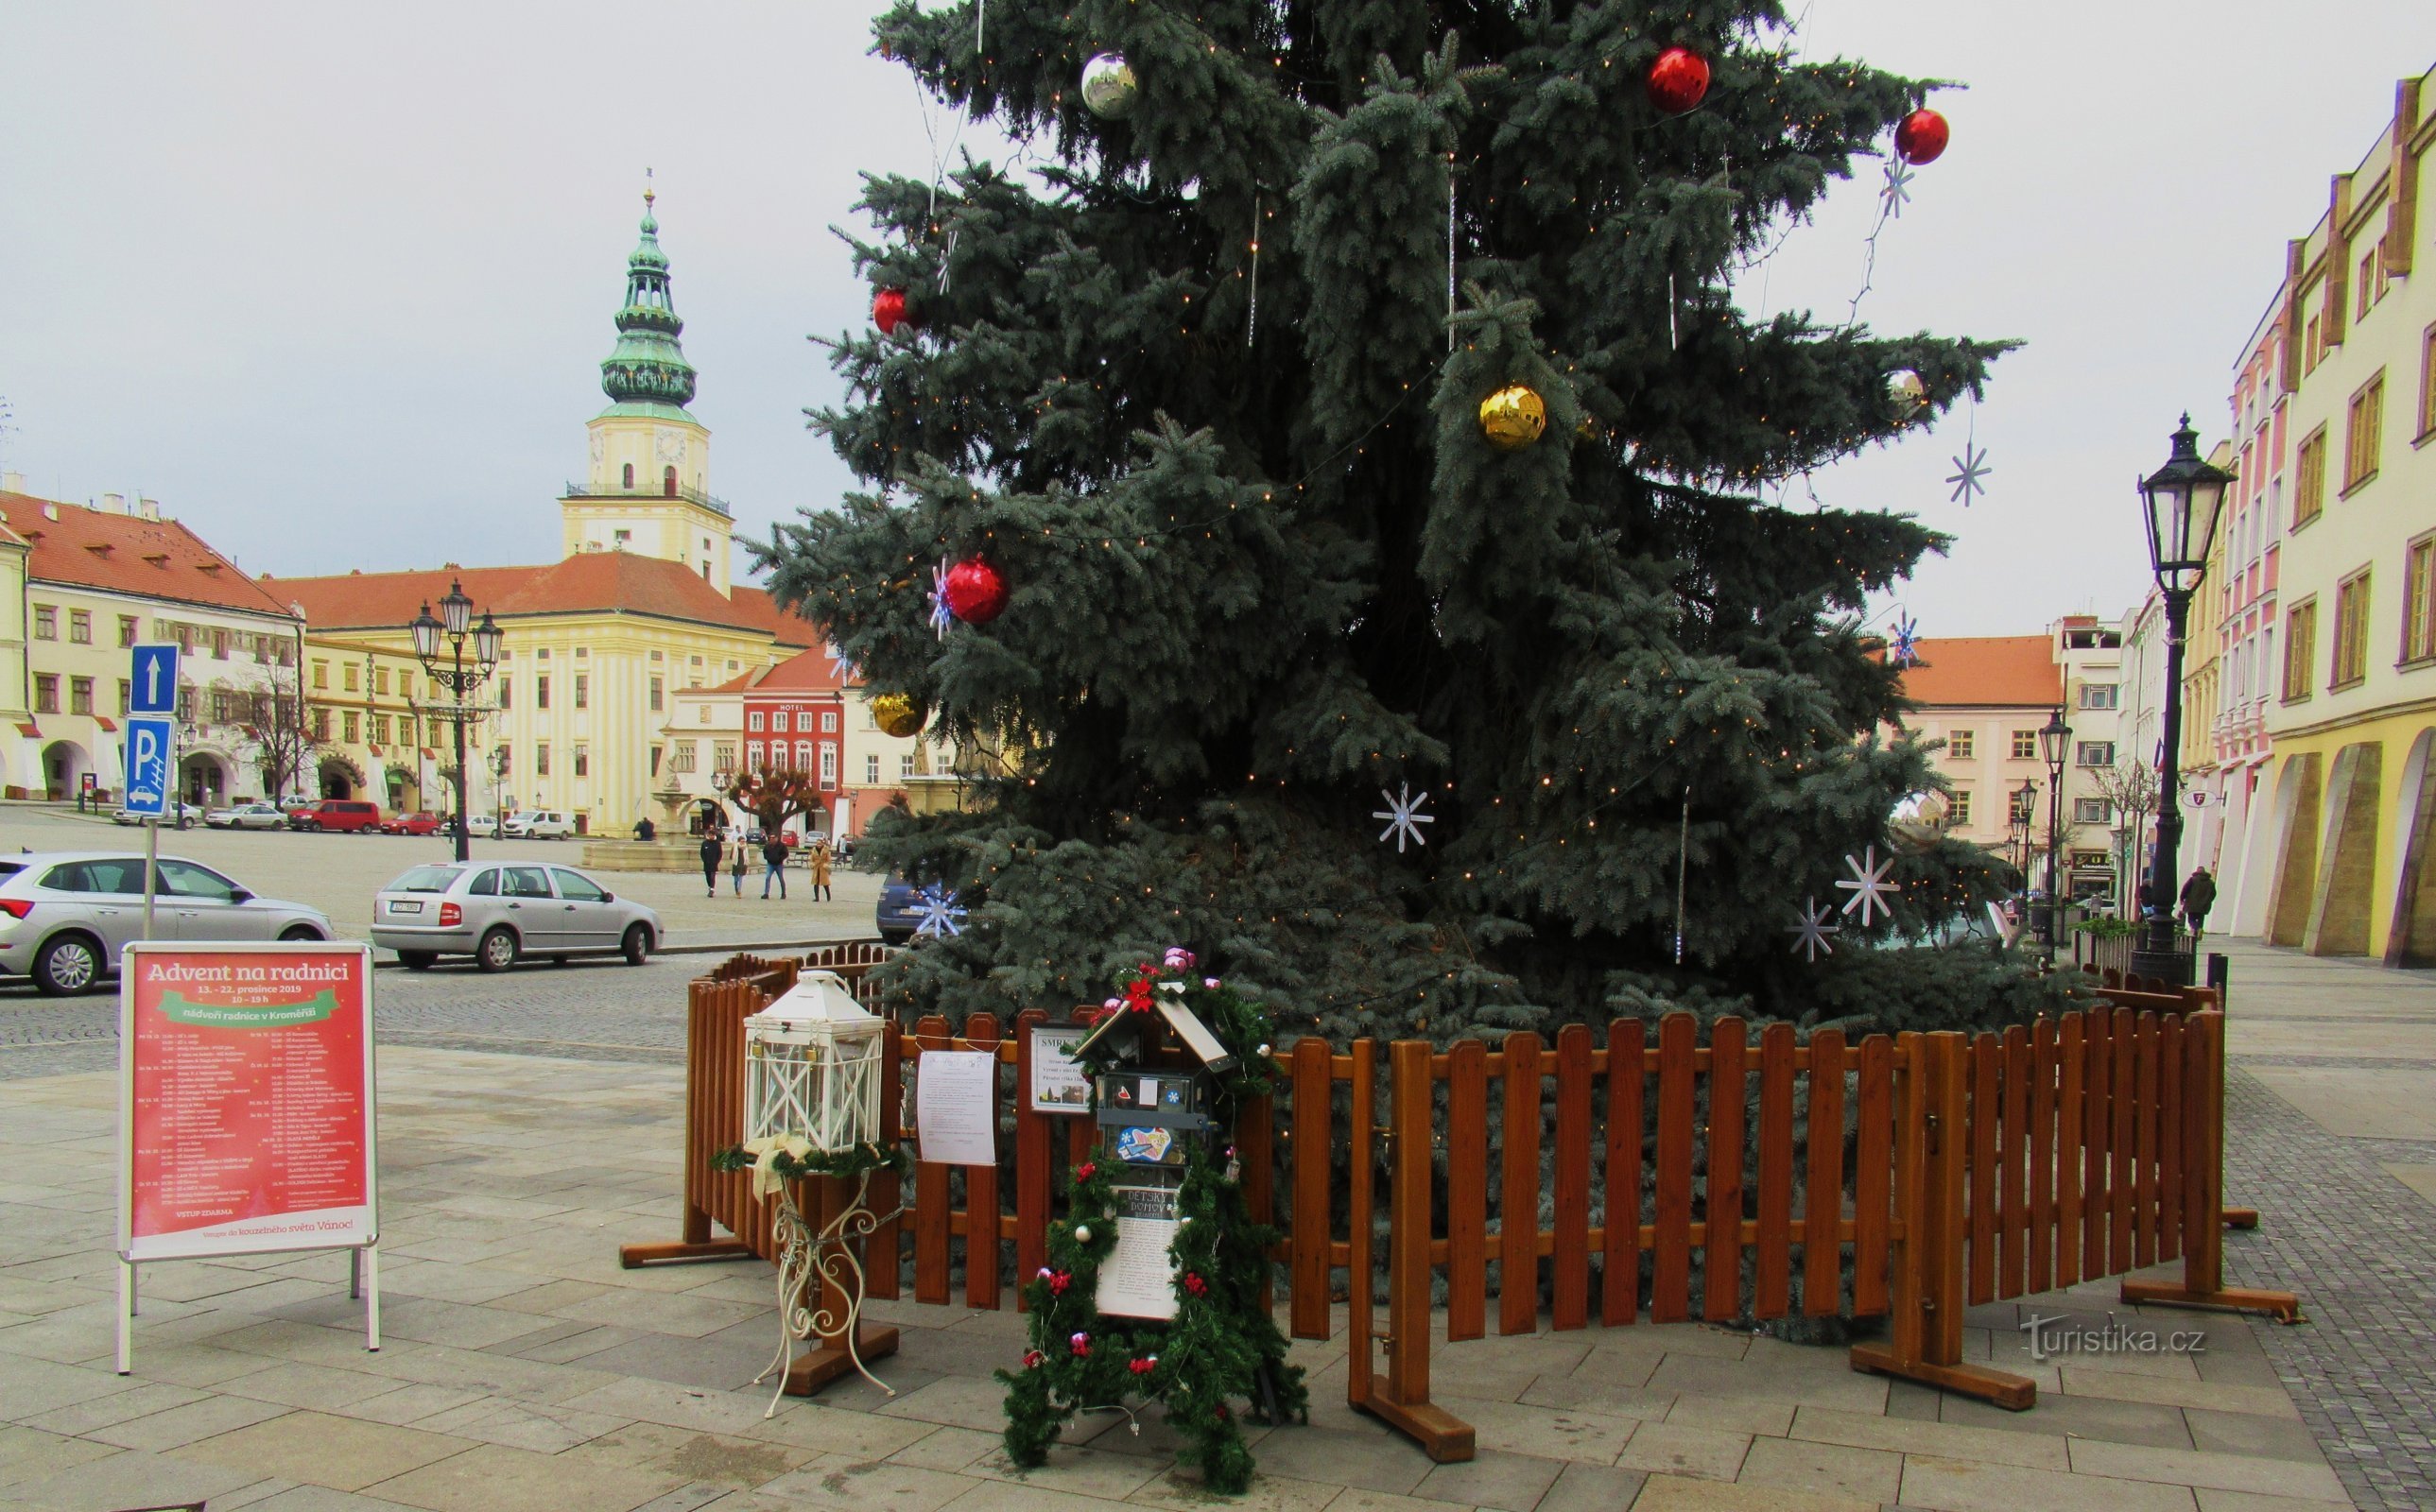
{"left": 558, "top": 187, "right": 735, "bottom": 594}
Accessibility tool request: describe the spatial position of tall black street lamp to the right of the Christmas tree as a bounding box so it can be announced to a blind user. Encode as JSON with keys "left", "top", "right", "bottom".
{"left": 2132, "top": 414, "right": 2234, "bottom": 986}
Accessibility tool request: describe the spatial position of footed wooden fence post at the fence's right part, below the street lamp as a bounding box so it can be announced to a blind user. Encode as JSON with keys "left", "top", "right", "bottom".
{"left": 1852, "top": 1032, "right": 2039, "bottom": 1412}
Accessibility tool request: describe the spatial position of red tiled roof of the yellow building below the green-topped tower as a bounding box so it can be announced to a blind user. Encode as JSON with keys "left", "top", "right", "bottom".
{"left": 263, "top": 550, "right": 819, "bottom": 645}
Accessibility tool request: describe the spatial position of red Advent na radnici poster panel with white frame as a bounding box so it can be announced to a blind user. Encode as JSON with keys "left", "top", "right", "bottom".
{"left": 119, "top": 945, "right": 377, "bottom": 1262}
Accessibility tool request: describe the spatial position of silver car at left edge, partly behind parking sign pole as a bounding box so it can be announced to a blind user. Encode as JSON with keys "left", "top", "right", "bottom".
{"left": 0, "top": 850, "right": 331, "bottom": 996}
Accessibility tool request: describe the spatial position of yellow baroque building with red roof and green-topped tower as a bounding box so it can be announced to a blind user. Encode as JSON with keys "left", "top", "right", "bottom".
{"left": 263, "top": 195, "right": 823, "bottom": 835}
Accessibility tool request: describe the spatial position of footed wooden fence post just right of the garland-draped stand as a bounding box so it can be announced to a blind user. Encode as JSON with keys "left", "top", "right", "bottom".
{"left": 1355, "top": 1040, "right": 1471, "bottom": 1463}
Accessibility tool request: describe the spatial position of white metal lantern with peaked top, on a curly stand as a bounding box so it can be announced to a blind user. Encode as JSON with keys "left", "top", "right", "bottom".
{"left": 746, "top": 971, "right": 887, "bottom": 1154}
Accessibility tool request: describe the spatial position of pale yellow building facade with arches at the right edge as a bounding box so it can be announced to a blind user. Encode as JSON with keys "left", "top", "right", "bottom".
{"left": 2254, "top": 71, "right": 2436, "bottom": 967}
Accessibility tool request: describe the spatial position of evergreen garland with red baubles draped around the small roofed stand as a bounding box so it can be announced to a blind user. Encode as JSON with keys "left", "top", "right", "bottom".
{"left": 999, "top": 947, "right": 1308, "bottom": 1495}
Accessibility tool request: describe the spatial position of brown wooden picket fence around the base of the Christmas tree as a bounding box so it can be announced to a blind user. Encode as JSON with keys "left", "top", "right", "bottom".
{"left": 621, "top": 957, "right": 2297, "bottom": 1461}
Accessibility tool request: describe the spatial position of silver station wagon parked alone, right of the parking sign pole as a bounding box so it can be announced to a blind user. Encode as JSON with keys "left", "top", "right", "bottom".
{"left": 372, "top": 862, "right": 660, "bottom": 971}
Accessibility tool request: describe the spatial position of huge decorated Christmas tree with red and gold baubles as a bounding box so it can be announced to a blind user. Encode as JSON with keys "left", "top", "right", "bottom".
{"left": 769, "top": 0, "right": 2039, "bottom": 1042}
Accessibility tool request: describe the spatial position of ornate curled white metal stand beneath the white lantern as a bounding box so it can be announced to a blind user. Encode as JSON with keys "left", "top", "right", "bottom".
{"left": 752, "top": 1171, "right": 901, "bottom": 1418}
